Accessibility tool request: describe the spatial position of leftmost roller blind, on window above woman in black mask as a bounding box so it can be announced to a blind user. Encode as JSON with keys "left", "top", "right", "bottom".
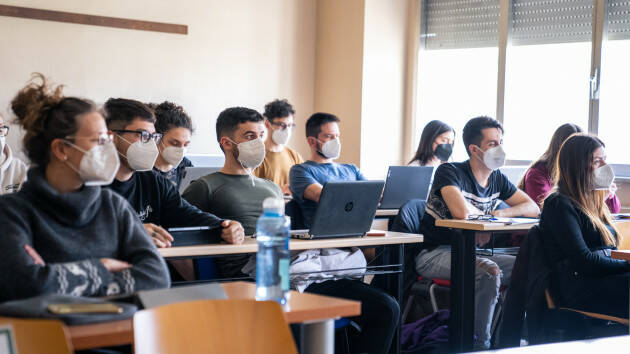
{"left": 422, "top": 0, "right": 499, "bottom": 49}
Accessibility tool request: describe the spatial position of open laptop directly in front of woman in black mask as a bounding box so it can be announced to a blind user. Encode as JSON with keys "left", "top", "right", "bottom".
{"left": 378, "top": 166, "right": 434, "bottom": 209}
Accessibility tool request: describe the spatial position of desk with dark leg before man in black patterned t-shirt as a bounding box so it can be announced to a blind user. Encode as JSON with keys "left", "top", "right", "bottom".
{"left": 435, "top": 220, "right": 536, "bottom": 353}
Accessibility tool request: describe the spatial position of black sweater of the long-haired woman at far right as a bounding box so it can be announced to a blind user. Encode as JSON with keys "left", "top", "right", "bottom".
{"left": 540, "top": 192, "right": 630, "bottom": 277}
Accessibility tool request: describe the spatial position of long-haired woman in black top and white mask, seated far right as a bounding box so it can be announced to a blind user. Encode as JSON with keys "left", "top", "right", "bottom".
{"left": 540, "top": 134, "right": 630, "bottom": 318}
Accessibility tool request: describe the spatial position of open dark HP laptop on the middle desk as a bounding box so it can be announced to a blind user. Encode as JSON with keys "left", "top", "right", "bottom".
{"left": 291, "top": 181, "right": 385, "bottom": 239}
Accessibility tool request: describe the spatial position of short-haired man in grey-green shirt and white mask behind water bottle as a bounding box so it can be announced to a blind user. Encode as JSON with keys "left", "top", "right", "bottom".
{"left": 182, "top": 107, "right": 282, "bottom": 277}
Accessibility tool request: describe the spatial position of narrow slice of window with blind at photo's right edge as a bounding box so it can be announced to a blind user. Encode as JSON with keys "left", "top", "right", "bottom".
{"left": 598, "top": 0, "right": 630, "bottom": 164}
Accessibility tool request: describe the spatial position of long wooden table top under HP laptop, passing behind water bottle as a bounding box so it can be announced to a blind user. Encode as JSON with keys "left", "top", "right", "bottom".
{"left": 158, "top": 231, "right": 424, "bottom": 258}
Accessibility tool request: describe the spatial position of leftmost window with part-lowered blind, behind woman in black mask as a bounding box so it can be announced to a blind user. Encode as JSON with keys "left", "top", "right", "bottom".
{"left": 415, "top": 0, "right": 499, "bottom": 161}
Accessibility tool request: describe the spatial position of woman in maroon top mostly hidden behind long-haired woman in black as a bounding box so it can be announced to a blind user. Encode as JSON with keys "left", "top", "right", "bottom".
{"left": 518, "top": 123, "right": 621, "bottom": 213}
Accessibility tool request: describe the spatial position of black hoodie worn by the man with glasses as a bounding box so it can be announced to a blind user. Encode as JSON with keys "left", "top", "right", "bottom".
{"left": 106, "top": 171, "right": 222, "bottom": 228}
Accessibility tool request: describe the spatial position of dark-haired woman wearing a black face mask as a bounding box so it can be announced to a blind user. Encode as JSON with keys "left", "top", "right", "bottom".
{"left": 409, "top": 120, "right": 455, "bottom": 167}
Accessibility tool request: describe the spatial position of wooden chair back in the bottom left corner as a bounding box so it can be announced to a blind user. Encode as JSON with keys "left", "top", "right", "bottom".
{"left": 0, "top": 317, "right": 74, "bottom": 354}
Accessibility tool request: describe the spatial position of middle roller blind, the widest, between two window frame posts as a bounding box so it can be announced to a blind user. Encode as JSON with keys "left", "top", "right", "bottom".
{"left": 511, "top": 0, "right": 593, "bottom": 45}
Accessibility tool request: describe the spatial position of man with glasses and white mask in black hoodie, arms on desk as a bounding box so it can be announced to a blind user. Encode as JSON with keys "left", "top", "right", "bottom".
{"left": 104, "top": 98, "right": 245, "bottom": 279}
